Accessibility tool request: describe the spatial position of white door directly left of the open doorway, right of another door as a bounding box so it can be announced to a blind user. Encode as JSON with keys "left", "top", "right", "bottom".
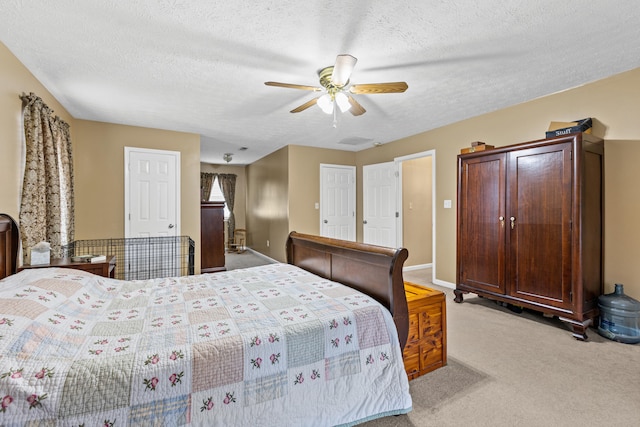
{"left": 362, "top": 162, "right": 398, "bottom": 248}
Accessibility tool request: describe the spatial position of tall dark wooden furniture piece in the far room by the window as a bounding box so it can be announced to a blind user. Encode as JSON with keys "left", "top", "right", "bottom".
{"left": 200, "top": 202, "right": 226, "bottom": 273}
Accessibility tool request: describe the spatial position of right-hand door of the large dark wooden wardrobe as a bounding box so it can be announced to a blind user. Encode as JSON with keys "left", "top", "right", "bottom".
{"left": 506, "top": 143, "right": 572, "bottom": 308}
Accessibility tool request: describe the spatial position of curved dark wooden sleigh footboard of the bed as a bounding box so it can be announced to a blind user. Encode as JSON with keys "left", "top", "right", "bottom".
{"left": 287, "top": 231, "right": 409, "bottom": 348}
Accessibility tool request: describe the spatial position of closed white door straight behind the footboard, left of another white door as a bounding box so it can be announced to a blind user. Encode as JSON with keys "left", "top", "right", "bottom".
{"left": 320, "top": 165, "right": 356, "bottom": 241}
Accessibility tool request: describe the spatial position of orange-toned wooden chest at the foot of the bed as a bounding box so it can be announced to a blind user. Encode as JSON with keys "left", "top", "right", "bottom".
{"left": 403, "top": 282, "right": 447, "bottom": 380}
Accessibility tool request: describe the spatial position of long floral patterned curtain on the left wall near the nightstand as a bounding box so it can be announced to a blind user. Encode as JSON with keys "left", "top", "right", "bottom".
{"left": 19, "top": 93, "right": 75, "bottom": 258}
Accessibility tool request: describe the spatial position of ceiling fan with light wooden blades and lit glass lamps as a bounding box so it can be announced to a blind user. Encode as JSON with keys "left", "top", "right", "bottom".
{"left": 264, "top": 54, "right": 409, "bottom": 116}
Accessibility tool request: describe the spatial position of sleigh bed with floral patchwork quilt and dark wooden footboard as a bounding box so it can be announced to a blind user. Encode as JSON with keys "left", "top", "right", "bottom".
{"left": 0, "top": 232, "right": 412, "bottom": 426}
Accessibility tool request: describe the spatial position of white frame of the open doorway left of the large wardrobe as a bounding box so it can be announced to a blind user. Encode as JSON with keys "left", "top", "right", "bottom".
{"left": 393, "top": 150, "right": 438, "bottom": 287}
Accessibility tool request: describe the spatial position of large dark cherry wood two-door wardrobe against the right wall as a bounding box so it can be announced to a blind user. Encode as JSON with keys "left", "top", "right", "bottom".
{"left": 454, "top": 133, "right": 604, "bottom": 340}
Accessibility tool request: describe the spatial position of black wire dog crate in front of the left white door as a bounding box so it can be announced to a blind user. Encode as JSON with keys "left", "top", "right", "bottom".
{"left": 62, "top": 236, "right": 195, "bottom": 280}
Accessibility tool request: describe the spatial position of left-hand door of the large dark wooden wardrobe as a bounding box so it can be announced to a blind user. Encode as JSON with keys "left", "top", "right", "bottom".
{"left": 457, "top": 153, "right": 506, "bottom": 294}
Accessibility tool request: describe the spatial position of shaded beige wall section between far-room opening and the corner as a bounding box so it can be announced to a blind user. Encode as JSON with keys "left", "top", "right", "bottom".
{"left": 246, "top": 147, "right": 290, "bottom": 261}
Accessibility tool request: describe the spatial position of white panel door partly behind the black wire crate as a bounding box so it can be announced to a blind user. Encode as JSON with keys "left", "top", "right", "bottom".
{"left": 124, "top": 147, "right": 181, "bottom": 280}
